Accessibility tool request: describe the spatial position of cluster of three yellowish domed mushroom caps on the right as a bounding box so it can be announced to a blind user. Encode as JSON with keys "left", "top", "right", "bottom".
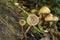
{"left": 38, "top": 6, "right": 58, "bottom": 21}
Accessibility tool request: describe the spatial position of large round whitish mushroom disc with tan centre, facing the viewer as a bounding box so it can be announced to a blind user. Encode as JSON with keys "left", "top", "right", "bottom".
{"left": 27, "top": 14, "right": 39, "bottom": 26}
